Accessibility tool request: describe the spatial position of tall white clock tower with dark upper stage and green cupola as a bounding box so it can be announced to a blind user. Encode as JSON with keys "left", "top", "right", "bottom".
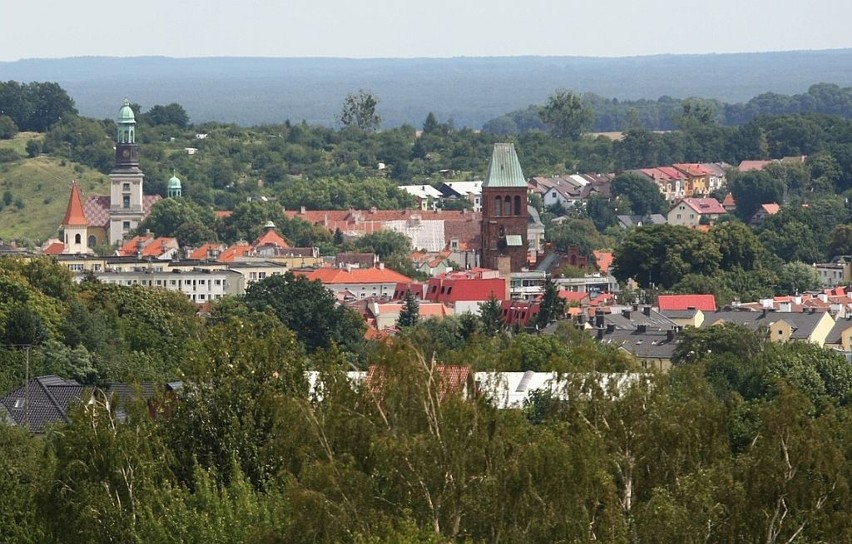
{"left": 109, "top": 100, "right": 145, "bottom": 245}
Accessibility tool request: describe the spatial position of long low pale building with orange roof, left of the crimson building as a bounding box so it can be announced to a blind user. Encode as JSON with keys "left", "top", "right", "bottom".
{"left": 293, "top": 264, "right": 411, "bottom": 299}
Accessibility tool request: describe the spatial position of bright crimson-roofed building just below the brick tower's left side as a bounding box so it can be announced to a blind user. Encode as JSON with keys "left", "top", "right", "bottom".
{"left": 420, "top": 268, "right": 509, "bottom": 315}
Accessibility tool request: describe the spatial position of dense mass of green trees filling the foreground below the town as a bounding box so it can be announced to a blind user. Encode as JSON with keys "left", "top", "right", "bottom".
{"left": 0, "top": 259, "right": 852, "bottom": 543}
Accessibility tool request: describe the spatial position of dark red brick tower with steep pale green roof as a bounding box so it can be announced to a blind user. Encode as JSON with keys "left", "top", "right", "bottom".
{"left": 481, "top": 144, "right": 529, "bottom": 272}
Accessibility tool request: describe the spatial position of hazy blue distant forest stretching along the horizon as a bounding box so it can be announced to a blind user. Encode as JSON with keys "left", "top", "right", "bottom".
{"left": 5, "top": 49, "right": 852, "bottom": 131}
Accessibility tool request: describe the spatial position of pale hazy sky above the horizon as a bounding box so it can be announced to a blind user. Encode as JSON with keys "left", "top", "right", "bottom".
{"left": 0, "top": 0, "right": 852, "bottom": 61}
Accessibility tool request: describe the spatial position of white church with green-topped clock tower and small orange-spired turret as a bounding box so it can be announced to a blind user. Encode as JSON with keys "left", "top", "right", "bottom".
{"left": 62, "top": 100, "right": 161, "bottom": 254}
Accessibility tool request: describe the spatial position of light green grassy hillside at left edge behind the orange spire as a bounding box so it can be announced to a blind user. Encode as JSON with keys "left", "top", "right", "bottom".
{"left": 0, "top": 133, "right": 109, "bottom": 244}
